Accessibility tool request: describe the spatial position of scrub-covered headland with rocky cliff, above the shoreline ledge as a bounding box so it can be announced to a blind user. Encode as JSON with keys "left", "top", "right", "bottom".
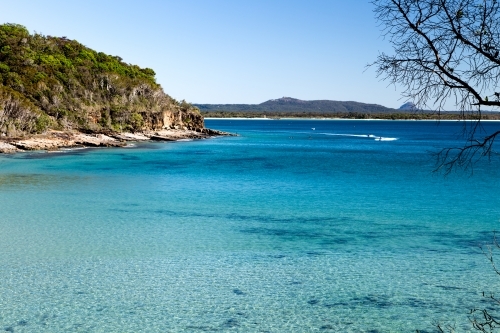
{"left": 0, "top": 24, "right": 204, "bottom": 137}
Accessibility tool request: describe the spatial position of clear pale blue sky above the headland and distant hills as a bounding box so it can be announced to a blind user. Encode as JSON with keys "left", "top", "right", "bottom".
{"left": 0, "top": 0, "right": 405, "bottom": 108}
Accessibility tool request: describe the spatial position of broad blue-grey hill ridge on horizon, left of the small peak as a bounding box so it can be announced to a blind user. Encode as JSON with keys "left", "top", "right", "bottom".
{"left": 193, "top": 97, "right": 396, "bottom": 113}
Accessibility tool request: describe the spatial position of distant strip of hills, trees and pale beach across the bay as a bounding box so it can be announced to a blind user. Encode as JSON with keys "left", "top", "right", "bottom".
{"left": 193, "top": 97, "right": 500, "bottom": 120}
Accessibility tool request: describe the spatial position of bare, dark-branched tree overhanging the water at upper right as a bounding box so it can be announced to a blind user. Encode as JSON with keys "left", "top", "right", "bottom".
{"left": 372, "top": 0, "right": 500, "bottom": 173}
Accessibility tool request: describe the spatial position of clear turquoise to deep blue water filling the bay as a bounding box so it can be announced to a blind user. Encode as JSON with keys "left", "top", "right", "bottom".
{"left": 0, "top": 120, "right": 500, "bottom": 332}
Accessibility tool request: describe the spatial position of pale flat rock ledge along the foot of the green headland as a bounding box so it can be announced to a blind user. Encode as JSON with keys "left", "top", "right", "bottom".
{"left": 0, "top": 128, "right": 236, "bottom": 154}
